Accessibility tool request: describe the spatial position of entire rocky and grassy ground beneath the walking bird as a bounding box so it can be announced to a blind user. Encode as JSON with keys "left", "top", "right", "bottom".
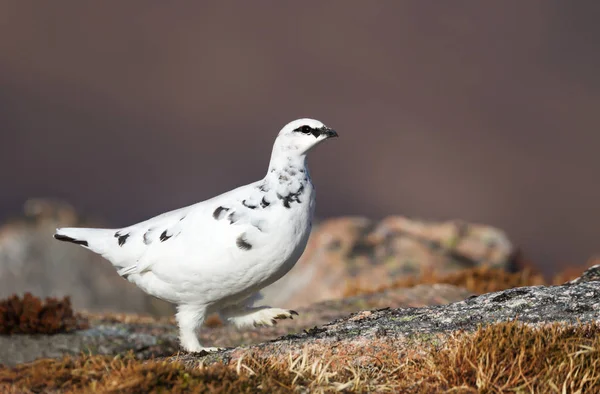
{"left": 0, "top": 267, "right": 600, "bottom": 393}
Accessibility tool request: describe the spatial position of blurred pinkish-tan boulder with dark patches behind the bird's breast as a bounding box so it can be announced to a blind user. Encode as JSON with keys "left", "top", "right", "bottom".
{"left": 262, "top": 216, "right": 516, "bottom": 308}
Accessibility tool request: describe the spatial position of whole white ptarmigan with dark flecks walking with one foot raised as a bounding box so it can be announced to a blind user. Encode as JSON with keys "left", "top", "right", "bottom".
{"left": 54, "top": 119, "right": 337, "bottom": 352}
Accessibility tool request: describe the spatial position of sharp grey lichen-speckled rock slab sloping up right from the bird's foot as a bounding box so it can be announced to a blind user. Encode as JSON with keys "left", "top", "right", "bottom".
{"left": 177, "top": 267, "right": 600, "bottom": 366}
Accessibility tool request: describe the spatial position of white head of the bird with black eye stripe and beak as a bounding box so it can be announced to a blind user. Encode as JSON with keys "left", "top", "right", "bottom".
{"left": 275, "top": 118, "right": 338, "bottom": 155}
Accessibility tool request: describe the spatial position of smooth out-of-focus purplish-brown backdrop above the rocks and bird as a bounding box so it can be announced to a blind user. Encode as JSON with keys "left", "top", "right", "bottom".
{"left": 0, "top": 0, "right": 600, "bottom": 312}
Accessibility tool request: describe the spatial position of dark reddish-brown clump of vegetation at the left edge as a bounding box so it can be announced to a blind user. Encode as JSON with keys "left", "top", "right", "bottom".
{"left": 0, "top": 293, "right": 88, "bottom": 335}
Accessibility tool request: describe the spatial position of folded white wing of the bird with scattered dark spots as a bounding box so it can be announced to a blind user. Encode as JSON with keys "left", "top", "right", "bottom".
{"left": 111, "top": 183, "right": 270, "bottom": 280}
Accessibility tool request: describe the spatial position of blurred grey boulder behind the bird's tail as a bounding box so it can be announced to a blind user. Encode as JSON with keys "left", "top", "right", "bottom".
{"left": 0, "top": 199, "right": 173, "bottom": 315}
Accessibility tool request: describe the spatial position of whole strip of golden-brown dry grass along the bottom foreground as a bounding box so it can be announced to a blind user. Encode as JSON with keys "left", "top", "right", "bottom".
{"left": 0, "top": 322, "right": 600, "bottom": 393}
